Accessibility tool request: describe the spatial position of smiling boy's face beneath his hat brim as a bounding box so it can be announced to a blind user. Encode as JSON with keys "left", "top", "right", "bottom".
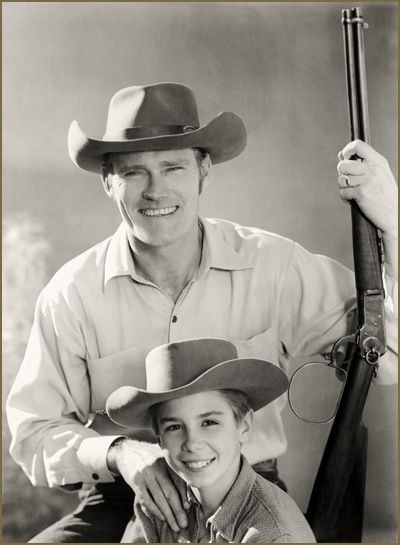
{"left": 158, "top": 391, "right": 251, "bottom": 494}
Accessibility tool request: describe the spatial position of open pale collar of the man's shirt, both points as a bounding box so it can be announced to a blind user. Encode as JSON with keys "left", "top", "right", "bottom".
{"left": 104, "top": 218, "right": 253, "bottom": 286}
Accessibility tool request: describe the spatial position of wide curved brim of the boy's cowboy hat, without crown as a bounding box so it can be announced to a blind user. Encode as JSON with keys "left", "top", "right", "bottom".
{"left": 106, "top": 358, "right": 288, "bottom": 429}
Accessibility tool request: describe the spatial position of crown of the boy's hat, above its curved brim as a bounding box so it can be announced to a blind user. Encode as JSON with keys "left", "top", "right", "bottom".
{"left": 146, "top": 338, "right": 238, "bottom": 393}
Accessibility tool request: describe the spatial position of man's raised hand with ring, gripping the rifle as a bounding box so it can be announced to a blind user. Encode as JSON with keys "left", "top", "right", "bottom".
{"left": 337, "top": 140, "right": 397, "bottom": 239}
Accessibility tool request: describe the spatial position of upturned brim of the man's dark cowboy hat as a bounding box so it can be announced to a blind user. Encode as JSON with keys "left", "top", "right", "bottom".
{"left": 68, "top": 112, "right": 247, "bottom": 174}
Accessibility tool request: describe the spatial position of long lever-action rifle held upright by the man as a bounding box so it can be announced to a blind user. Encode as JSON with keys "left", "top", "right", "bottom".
{"left": 306, "top": 8, "right": 386, "bottom": 543}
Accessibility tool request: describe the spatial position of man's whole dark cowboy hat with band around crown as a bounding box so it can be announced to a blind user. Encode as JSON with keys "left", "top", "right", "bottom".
{"left": 68, "top": 83, "right": 247, "bottom": 174}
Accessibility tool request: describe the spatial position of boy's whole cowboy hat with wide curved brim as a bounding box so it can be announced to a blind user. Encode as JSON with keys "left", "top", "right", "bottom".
{"left": 106, "top": 338, "right": 288, "bottom": 428}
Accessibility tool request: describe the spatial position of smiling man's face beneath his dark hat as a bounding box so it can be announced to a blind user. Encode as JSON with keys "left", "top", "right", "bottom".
{"left": 106, "top": 148, "right": 206, "bottom": 246}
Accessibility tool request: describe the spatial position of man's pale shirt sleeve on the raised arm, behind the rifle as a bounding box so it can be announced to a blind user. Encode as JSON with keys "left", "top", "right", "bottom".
{"left": 279, "top": 243, "right": 397, "bottom": 384}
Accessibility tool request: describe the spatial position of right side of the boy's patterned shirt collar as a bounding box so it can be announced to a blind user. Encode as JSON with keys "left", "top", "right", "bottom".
{"left": 207, "top": 456, "right": 256, "bottom": 542}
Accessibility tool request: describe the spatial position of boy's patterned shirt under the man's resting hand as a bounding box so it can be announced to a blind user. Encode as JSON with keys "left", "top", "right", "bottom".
{"left": 121, "top": 457, "right": 315, "bottom": 543}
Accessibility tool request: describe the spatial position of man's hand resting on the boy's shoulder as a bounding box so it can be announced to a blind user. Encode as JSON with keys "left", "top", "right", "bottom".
{"left": 107, "top": 438, "right": 189, "bottom": 532}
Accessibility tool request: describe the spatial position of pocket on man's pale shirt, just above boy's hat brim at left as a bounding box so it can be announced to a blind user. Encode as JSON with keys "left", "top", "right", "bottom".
{"left": 87, "top": 346, "right": 148, "bottom": 411}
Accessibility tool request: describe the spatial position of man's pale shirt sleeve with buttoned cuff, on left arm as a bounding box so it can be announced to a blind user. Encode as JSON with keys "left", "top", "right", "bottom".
{"left": 7, "top": 290, "right": 120, "bottom": 487}
